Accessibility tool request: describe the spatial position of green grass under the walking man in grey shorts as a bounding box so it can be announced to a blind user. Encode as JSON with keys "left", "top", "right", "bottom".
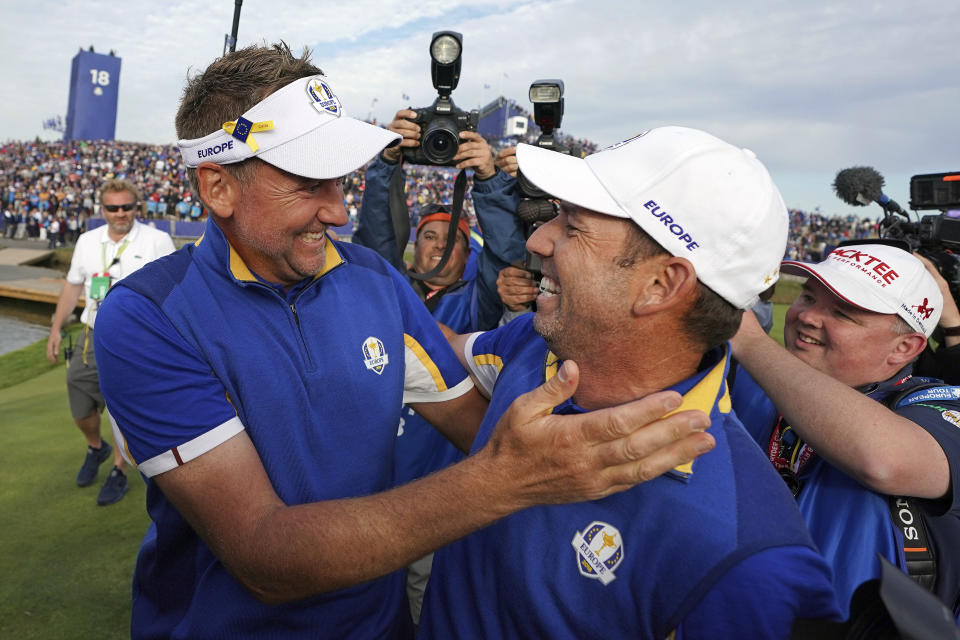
{"left": 0, "top": 358, "right": 149, "bottom": 640}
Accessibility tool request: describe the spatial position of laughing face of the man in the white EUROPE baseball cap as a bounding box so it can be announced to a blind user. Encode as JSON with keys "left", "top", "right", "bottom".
{"left": 527, "top": 202, "right": 637, "bottom": 358}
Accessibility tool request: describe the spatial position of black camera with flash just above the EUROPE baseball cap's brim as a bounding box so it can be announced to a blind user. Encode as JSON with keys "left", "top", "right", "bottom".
{"left": 517, "top": 80, "right": 572, "bottom": 280}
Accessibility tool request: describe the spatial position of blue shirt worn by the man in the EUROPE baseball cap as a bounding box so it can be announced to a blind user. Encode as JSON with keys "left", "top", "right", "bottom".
{"left": 420, "top": 314, "right": 837, "bottom": 640}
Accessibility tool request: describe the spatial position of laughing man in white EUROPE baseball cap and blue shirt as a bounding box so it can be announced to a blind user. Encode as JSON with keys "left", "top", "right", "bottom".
{"left": 420, "top": 127, "right": 838, "bottom": 639}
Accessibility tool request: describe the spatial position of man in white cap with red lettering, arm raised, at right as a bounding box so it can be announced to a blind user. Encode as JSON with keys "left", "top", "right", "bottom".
{"left": 733, "top": 241, "right": 960, "bottom": 614}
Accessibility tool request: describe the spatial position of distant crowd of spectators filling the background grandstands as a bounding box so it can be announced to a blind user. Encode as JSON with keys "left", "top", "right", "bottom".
{"left": 0, "top": 136, "right": 876, "bottom": 261}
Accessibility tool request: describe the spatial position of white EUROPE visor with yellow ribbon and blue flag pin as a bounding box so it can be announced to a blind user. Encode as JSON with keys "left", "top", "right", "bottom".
{"left": 177, "top": 75, "right": 401, "bottom": 180}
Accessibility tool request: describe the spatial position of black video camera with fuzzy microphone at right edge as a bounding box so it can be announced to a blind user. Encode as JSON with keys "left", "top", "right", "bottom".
{"left": 833, "top": 167, "right": 960, "bottom": 301}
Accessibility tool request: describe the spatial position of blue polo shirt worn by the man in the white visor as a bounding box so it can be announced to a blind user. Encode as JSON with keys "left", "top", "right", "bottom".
{"left": 96, "top": 221, "right": 472, "bottom": 639}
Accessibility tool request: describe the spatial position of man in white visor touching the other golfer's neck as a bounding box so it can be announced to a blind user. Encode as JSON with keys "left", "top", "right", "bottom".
{"left": 96, "top": 44, "right": 712, "bottom": 639}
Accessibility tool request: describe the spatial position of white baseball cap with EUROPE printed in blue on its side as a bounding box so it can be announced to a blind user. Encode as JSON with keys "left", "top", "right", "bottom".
{"left": 517, "top": 126, "right": 788, "bottom": 309}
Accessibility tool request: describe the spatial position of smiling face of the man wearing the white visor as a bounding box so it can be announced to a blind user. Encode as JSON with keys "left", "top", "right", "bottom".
{"left": 224, "top": 163, "right": 347, "bottom": 286}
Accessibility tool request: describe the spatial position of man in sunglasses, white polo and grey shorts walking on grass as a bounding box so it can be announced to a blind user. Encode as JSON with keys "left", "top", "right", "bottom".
{"left": 47, "top": 179, "right": 174, "bottom": 505}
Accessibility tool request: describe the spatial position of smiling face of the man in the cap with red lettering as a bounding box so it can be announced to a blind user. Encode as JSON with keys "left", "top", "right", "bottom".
{"left": 783, "top": 278, "right": 909, "bottom": 387}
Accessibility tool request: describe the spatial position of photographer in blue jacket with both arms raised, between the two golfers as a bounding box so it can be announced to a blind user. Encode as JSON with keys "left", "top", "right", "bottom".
{"left": 353, "top": 109, "right": 525, "bottom": 623}
